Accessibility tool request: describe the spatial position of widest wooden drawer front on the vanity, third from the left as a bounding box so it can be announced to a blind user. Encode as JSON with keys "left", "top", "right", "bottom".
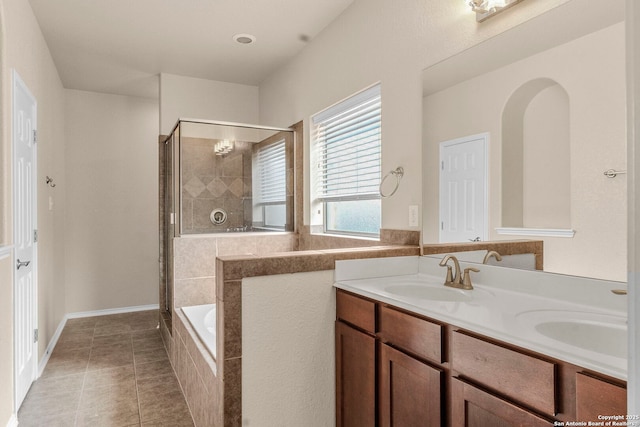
{"left": 451, "top": 331, "right": 557, "bottom": 416}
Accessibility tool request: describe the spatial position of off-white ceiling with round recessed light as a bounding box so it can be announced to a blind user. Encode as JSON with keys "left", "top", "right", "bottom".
{"left": 29, "top": 0, "right": 353, "bottom": 97}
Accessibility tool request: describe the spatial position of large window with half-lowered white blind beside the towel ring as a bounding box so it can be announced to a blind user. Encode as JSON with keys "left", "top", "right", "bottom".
{"left": 311, "top": 85, "right": 381, "bottom": 237}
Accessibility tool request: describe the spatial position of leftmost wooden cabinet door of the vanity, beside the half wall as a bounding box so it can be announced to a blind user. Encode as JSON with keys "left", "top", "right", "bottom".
{"left": 336, "top": 322, "right": 376, "bottom": 427}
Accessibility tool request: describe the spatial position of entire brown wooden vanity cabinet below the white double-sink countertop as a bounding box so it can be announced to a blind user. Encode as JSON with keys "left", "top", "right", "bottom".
{"left": 336, "top": 289, "right": 626, "bottom": 427}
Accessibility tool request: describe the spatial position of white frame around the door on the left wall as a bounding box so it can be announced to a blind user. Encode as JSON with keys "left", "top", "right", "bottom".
{"left": 9, "top": 69, "right": 38, "bottom": 414}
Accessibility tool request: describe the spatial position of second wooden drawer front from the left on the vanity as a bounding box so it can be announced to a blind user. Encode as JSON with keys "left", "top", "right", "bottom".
{"left": 378, "top": 306, "right": 443, "bottom": 363}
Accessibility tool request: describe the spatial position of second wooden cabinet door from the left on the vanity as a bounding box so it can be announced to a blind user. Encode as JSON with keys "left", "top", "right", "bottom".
{"left": 378, "top": 344, "right": 443, "bottom": 427}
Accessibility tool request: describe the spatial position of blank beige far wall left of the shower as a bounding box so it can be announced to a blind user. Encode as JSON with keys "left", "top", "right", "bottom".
{"left": 65, "top": 90, "right": 159, "bottom": 313}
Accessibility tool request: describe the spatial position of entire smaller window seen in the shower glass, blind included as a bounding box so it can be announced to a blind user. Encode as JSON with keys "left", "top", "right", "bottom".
{"left": 252, "top": 139, "right": 287, "bottom": 230}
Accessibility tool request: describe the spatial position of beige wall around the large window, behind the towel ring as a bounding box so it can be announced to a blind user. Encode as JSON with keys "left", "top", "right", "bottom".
{"left": 255, "top": 0, "right": 565, "bottom": 229}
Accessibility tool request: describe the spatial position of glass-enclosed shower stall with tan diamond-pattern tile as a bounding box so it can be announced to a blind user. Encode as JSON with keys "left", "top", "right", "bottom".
{"left": 159, "top": 119, "right": 294, "bottom": 315}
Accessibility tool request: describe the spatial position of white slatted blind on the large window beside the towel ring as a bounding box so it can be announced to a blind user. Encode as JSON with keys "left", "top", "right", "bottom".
{"left": 312, "top": 85, "right": 381, "bottom": 201}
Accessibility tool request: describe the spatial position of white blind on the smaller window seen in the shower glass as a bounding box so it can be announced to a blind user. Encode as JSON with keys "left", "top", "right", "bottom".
{"left": 253, "top": 139, "right": 287, "bottom": 205}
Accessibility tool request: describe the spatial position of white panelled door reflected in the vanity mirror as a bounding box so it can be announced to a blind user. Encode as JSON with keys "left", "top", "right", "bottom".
{"left": 440, "top": 134, "right": 489, "bottom": 243}
